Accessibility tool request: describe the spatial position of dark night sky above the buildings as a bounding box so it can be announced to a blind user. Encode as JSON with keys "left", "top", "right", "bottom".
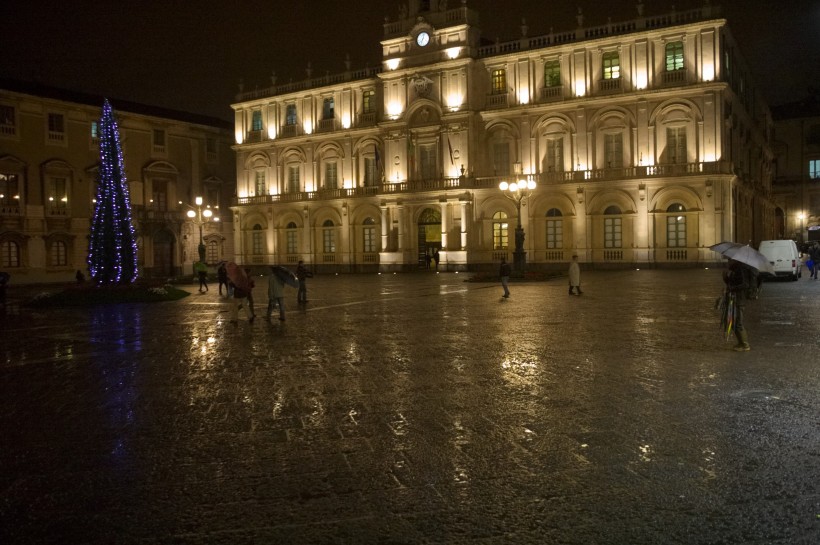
{"left": 0, "top": 0, "right": 820, "bottom": 120}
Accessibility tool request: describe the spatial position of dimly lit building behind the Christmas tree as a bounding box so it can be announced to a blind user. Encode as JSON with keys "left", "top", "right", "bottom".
{"left": 0, "top": 81, "right": 235, "bottom": 283}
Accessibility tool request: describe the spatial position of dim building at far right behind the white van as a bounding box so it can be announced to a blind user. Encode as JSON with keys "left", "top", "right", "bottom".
{"left": 773, "top": 89, "right": 820, "bottom": 248}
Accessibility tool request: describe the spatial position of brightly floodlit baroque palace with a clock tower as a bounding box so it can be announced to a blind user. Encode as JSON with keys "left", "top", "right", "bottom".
{"left": 231, "top": 0, "right": 774, "bottom": 272}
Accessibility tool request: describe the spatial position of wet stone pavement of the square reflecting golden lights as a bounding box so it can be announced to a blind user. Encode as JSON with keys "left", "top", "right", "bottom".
{"left": 0, "top": 270, "right": 820, "bottom": 545}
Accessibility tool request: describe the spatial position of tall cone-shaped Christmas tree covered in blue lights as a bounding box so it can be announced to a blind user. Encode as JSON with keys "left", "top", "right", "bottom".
{"left": 88, "top": 99, "right": 137, "bottom": 285}
